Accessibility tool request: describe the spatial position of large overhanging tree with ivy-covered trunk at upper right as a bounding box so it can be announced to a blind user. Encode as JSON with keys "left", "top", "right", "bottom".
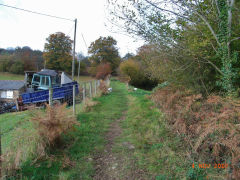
{"left": 109, "top": 0, "right": 240, "bottom": 92}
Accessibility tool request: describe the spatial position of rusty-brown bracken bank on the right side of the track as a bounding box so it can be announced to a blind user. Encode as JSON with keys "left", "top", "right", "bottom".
{"left": 150, "top": 87, "right": 240, "bottom": 179}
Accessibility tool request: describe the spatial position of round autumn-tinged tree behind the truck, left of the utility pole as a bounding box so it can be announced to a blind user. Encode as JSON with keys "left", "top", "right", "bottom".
{"left": 43, "top": 32, "right": 73, "bottom": 73}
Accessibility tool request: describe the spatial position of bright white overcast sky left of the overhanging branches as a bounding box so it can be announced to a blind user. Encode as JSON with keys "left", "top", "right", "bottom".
{"left": 0, "top": 0, "right": 143, "bottom": 56}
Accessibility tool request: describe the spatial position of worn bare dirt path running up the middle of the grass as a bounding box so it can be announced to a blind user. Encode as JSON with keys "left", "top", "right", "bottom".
{"left": 93, "top": 108, "right": 146, "bottom": 180}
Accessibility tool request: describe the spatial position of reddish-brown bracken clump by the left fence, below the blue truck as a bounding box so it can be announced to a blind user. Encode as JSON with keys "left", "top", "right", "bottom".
{"left": 32, "top": 104, "right": 79, "bottom": 146}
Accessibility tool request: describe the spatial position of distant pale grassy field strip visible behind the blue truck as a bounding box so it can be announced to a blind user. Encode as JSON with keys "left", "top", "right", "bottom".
{"left": 0, "top": 72, "right": 93, "bottom": 82}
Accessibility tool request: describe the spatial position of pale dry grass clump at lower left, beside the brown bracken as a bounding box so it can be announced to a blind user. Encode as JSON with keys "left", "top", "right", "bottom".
{"left": 2, "top": 126, "right": 45, "bottom": 176}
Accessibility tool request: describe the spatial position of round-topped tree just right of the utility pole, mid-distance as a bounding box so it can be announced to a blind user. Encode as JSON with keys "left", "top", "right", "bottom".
{"left": 88, "top": 36, "right": 120, "bottom": 72}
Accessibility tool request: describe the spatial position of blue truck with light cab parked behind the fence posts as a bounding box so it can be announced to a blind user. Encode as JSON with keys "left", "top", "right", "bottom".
{"left": 18, "top": 69, "right": 79, "bottom": 110}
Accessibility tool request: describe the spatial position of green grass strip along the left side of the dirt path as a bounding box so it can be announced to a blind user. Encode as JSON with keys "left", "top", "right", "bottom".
{"left": 15, "top": 82, "right": 127, "bottom": 180}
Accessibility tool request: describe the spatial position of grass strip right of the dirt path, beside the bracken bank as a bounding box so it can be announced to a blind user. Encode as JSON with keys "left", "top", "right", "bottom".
{"left": 114, "top": 86, "right": 202, "bottom": 179}
